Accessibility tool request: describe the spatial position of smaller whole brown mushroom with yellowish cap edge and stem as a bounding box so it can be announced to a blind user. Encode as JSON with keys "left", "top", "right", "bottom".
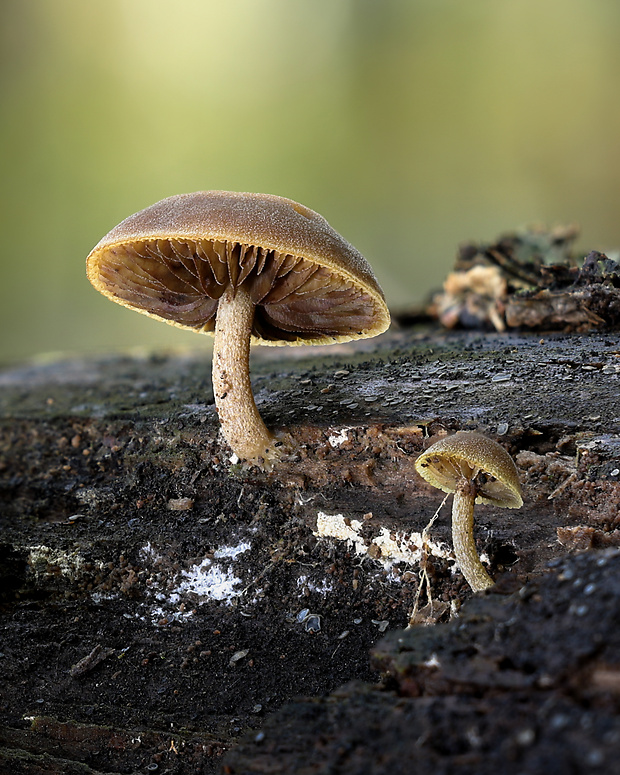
{"left": 415, "top": 431, "right": 523, "bottom": 592}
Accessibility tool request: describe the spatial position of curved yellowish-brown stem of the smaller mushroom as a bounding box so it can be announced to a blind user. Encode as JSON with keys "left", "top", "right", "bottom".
{"left": 452, "top": 479, "right": 495, "bottom": 592}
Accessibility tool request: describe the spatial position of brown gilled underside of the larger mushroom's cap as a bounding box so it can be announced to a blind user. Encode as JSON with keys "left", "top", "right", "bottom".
{"left": 98, "top": 239, "right": 376, "bottom": 342}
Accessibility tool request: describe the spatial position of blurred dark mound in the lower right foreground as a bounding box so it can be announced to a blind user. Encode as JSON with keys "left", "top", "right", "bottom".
{"left": 226, "top": 549, "right": 620, "bottom": 775}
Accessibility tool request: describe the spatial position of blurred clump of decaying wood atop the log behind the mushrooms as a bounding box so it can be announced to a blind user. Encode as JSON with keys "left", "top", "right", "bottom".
{"left": 404, "top": 227, "right": 620, "bottom": 333}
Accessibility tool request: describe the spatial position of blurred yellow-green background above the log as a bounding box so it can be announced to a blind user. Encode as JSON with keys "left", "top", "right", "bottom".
{"left": 0, "top": 0, "right": 620, "bottom": 363}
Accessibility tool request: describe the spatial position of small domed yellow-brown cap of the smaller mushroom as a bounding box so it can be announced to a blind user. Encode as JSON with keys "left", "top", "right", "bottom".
{"left": 415, "top": 431, "right": 523, "bottom": 509}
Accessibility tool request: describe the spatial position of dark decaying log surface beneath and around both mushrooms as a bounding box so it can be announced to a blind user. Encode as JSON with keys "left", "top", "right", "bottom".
{"left": 0, "top": 329, "right": 620, "bottom": 774}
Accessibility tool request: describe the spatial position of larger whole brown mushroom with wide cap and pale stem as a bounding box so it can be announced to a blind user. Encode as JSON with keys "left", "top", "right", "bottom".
{"left": 86, "top": 191, "right": 390, "bottom": 464}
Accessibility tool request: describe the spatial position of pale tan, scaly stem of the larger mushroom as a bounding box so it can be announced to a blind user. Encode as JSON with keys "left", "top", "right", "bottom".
{"left": 212, "top": 285, "right": 276, "bottom": 461}
